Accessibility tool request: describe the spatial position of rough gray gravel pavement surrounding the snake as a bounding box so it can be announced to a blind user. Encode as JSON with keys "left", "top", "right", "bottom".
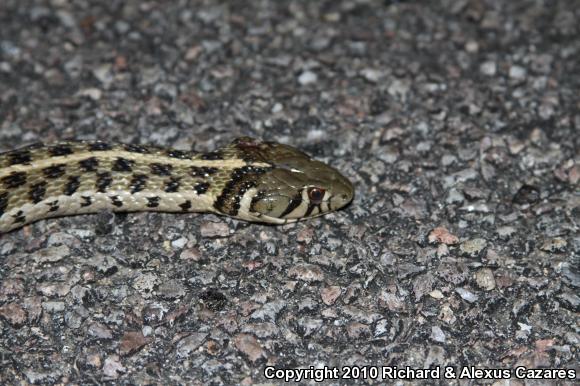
{"left": 0, "top": 0, "right": 580, "bottom": 385}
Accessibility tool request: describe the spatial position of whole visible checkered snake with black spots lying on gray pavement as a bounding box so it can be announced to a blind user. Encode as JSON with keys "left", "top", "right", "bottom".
{"left": 0, "top": 137, "right": 354, "bottom": 233}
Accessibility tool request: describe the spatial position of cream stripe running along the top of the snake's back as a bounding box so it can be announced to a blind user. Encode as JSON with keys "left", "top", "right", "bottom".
{"left": 0, "top": 150, "right": 271, "bottom": 178}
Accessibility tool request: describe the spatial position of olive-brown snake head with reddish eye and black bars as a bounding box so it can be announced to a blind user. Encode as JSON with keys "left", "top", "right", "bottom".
{"left": 232, "top": 137, "right": 354, "bottom": 224}
